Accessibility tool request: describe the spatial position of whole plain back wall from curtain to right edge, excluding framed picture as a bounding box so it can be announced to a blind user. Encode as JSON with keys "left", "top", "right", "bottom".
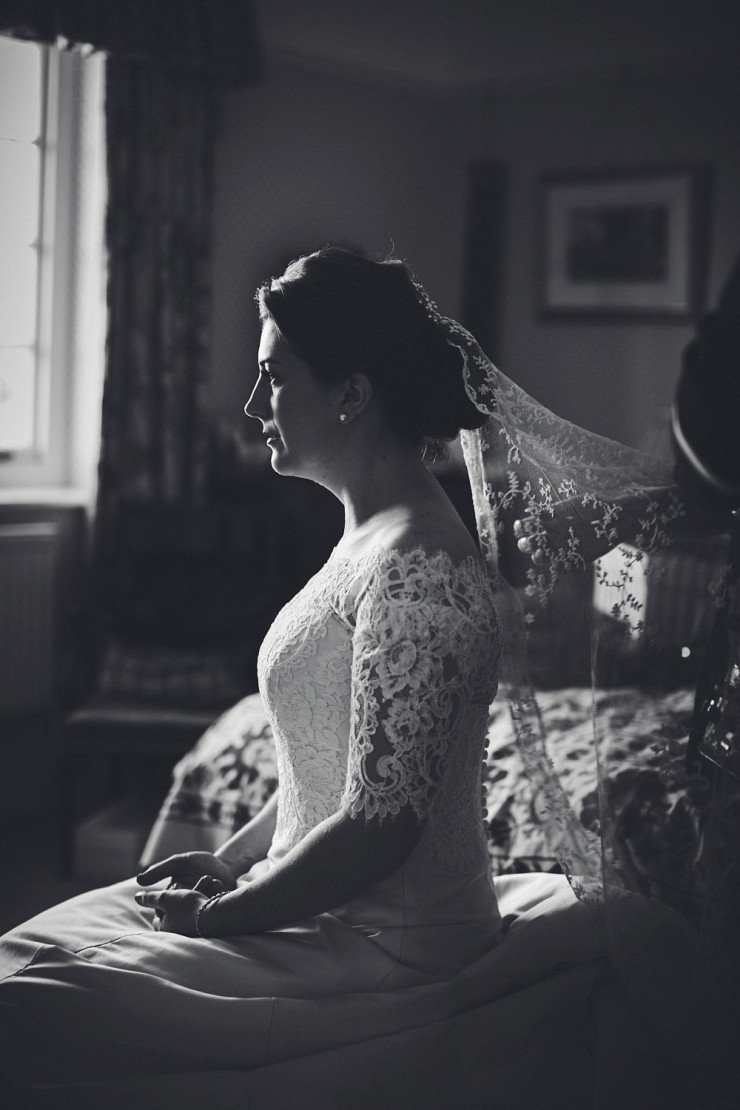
{"left": 211, "top": 58, "right": 740, "bottom": 445}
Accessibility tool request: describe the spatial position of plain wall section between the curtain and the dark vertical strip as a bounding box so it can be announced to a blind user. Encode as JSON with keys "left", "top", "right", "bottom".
{"left": 211, "top": 65, "right": 474, "bottom": 425}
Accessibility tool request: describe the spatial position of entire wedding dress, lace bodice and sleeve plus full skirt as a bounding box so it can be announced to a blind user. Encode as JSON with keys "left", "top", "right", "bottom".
{"left": 0, "top": 548, "right": 701, "bottom": 1110}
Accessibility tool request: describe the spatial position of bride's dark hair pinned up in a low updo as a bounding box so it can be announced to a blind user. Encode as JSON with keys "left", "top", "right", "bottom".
{"left": 256, "top": 246, "right": 486, "bottom": 454}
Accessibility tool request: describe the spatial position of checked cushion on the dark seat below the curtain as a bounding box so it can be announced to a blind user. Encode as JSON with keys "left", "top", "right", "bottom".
{"left": 98, "top": 643, "right": 249, "bottom": 709}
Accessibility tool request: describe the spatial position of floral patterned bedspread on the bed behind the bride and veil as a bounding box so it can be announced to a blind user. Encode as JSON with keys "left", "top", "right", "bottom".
{"left": 142, "top": 687, "right": 692, "bottom": 874}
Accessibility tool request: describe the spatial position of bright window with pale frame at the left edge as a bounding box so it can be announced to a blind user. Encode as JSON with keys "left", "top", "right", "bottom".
{"left": 0, "top": 37, "right": 105, "bottom": 495}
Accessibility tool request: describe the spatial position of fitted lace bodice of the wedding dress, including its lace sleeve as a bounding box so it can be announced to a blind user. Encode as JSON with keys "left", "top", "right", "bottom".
{"left": 260, "top": 548, "right": 500, "bottom": 867}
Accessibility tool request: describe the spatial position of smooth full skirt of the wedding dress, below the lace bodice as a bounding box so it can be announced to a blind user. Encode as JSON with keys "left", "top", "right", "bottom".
{"left": 0, "top": 875, "right": 705, "bottom": 1110}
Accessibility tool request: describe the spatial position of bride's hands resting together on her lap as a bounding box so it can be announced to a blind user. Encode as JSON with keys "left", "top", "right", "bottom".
{"left": 134, "top": 851, "right": 236, "bottom": 937}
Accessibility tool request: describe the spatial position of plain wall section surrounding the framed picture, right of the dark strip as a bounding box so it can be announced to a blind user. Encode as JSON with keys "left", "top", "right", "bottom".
{"left": 459, "top": 63, "right": 740, "bottom": 445}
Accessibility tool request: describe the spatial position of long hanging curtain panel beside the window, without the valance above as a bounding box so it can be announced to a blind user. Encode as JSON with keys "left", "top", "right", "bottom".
{"left": 99, "top": 58, "right": 215, "bottom": 528}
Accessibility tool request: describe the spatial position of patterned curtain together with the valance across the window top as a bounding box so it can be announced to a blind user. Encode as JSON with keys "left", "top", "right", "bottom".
{"left": 0, "top": 0, "right": 262, "bottom": 547}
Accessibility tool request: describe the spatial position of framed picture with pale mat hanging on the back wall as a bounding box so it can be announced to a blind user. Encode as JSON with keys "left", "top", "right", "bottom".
{"left": 541, "top": 167, "right": 708, "bottom": 320}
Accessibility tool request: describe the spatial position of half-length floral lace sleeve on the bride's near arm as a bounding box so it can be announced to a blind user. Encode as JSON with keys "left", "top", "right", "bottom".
{"left": 343, "top": 555, "right": 495, "bottom": 820}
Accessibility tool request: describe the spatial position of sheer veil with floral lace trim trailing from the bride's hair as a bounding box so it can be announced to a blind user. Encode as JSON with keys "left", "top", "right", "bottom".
{"left": 457, "top": 321, "right": 683, "bottom": 899}
